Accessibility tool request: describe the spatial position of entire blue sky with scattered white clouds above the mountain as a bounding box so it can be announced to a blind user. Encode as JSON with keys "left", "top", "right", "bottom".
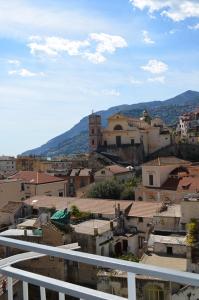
{"left": 0, "top": 0, "right": 199, "bottom": 155}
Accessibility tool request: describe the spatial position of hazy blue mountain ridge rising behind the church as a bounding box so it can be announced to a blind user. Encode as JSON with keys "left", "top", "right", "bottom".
{"left": 22, "top": 90, "right": 199, "bottom": 156}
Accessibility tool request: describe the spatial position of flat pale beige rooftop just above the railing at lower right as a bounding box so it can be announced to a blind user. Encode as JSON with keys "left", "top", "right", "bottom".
{"left": 141, "top": 253, "right": 187, "bottom": 271}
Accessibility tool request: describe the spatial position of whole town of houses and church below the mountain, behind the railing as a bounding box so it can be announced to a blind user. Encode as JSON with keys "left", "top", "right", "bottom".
{"left": 0, "top": 110, "right": 199, "bottom": 300}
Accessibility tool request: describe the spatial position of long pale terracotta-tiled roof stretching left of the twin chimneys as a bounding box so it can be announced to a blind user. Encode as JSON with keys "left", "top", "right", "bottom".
{"left": 24, "top": 196, "right": 132, "bottom": 215}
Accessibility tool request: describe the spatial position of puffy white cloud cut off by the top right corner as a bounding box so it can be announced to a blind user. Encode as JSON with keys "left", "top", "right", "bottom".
{"left": 129, "top": 0, "right": 199, "bottom": 22}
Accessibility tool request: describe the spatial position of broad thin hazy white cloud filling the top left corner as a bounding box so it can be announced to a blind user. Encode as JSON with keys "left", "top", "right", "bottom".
{"left": 0, "top": 0, "right": 114, "bottom": 39}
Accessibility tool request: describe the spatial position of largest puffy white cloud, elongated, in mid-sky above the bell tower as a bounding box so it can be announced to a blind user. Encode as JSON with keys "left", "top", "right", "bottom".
{"left": 27, "top": 33, "right": 127, "bottom": 64}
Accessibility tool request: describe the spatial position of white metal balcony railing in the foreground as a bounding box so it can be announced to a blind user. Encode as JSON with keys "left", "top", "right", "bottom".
{"left": 0, "top": 237, "right": 199, "bottom": 300}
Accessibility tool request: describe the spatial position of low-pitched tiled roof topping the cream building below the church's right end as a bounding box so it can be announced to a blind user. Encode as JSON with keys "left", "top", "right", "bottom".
{"left": 143, "top": 156, "right": 191, "bottom": 166}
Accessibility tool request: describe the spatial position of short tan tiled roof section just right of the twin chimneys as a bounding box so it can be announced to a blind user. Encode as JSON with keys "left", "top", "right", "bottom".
{"left": 128, "top": 201, "right": 163, "bottom": 218}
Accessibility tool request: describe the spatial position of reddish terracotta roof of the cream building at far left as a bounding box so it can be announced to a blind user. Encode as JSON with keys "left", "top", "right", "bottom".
{"left": 9, "top": 171, "right": 64, "bottom": 184}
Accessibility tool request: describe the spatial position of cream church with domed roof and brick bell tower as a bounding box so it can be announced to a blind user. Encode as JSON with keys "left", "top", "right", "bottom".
{"left": 89, "top": 110, "right": 171, "bottom": 162}
